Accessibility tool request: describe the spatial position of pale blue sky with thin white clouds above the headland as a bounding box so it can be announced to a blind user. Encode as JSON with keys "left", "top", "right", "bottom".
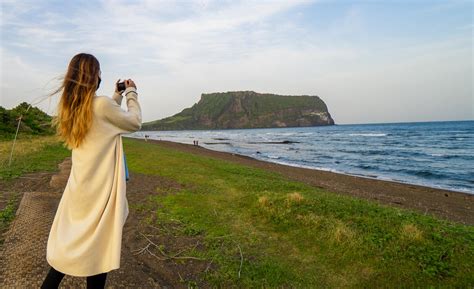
{"left": 0, "top": 0, "right": 474, "bottom": 124}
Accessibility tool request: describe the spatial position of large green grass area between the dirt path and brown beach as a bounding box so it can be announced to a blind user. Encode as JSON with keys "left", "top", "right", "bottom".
{"left": 124, "top": 138, "right": 474, "bottom": 288}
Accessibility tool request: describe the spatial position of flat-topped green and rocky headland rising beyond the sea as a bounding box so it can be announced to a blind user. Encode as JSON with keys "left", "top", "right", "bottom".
{"left": 141, "top": 91, "right": 334, "bottom": 130}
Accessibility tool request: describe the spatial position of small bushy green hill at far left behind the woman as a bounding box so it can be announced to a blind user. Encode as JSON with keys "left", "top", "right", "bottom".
{"left": 0, "top": 102, "right": 54, "bottom": 139}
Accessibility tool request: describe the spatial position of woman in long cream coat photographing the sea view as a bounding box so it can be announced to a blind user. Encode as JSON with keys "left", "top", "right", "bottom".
{"left": 41, "top": 53, "right": 142, "bottom": 288}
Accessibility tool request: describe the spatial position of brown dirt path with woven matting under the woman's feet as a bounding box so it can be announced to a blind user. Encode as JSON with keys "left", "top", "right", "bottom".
{"left": 0, "top": 158, "right": 207, "bottom": 288}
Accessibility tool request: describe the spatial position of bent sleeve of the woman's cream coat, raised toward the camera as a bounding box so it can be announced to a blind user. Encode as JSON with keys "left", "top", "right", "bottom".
{"left": 102, "top": 87, "right": 142, "bottom": 133}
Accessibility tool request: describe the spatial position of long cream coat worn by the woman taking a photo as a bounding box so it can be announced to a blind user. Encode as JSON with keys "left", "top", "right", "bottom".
{"left": 46, "top": 87, "right": 142, "bottom": 276}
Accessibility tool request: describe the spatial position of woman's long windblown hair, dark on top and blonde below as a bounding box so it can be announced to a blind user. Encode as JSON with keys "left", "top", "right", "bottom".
{"left": 51, "top": 53, "right": 100, "bottom": 150}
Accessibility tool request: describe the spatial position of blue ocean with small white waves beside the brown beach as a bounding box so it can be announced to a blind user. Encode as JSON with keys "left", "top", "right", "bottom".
{"left": 127, "top": 121, "right": 474, "bottom": 194}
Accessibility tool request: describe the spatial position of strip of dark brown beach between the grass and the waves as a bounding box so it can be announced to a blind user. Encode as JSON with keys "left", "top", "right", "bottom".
{"left": 130, "top": 137, "right": 474, "bottom": 225}
